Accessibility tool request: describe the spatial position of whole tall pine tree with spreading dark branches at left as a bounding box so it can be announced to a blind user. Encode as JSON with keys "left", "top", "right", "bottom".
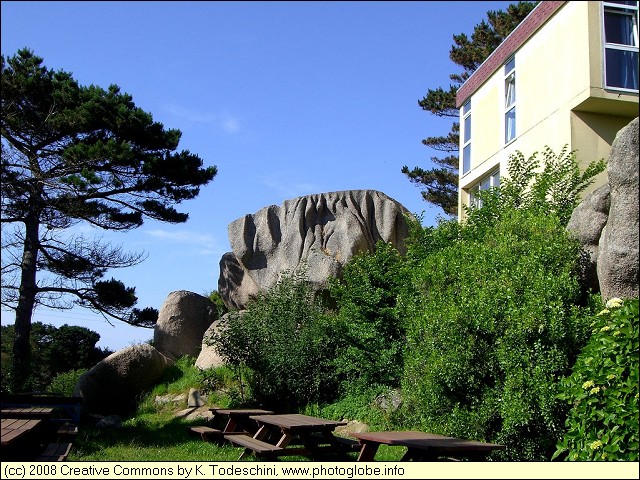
{"left": 0, "top": 49, "right": 217, "bottom": 392}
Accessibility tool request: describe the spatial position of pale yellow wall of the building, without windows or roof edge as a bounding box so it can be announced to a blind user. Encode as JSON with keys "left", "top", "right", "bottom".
{"left": 458, "top": 1, "right": 638, "bottom": 218}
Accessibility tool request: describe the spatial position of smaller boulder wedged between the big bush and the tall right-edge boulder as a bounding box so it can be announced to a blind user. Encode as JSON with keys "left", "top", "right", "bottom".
{"left": 567, "top": 183, "right": 611, "bottom": 292}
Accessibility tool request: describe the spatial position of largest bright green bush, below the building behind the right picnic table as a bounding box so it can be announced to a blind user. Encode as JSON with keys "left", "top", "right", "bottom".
{"left": 401, "top": 209, "right": 588, "bottom": 460}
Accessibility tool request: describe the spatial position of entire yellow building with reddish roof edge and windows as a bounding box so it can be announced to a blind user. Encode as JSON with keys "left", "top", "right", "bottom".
{"left": 456, "top": 1, "right": 638, "bottom": 218}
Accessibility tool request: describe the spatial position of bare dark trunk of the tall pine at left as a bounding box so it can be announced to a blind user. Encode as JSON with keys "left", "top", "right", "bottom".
{"left": 11, "top": 215, "right": 39, "bottom": 393}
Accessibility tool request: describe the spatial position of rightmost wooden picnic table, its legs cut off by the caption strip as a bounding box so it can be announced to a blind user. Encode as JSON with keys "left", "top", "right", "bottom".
{"left": 349, "top": 431, "right": 505, "bottom": 461}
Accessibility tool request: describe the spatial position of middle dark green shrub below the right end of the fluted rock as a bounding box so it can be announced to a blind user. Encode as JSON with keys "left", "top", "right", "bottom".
{"left": 330, "top": 242, "right": 404, "bottom": 390}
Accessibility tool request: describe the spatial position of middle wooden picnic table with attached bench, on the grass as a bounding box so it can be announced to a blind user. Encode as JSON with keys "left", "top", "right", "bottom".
{"left": 225, "top": 414, "right": 347, "bottom": 458}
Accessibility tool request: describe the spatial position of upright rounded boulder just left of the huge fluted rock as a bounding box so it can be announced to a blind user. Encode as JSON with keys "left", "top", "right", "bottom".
{"left": 153, "top": 290, "right": 218, "bottom": 360}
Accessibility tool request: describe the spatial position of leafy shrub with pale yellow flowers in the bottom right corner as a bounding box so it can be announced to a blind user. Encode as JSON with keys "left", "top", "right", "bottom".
{"left": 553, "top": 299, "right": 640, "bottom": 462}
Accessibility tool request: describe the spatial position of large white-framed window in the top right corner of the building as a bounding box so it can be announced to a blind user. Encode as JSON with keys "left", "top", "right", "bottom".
{"left": 602, "top": 1, "right": 638, "bottom": 91}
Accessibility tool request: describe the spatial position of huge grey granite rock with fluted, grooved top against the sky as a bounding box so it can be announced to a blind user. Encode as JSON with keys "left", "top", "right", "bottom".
{"left": 218, "top": 190, "right": 409, "bottom": 310}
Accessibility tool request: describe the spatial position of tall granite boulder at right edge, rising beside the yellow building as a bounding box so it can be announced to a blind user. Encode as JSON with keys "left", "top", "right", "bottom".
{"left": 597, "top": 117, "right": 640, "bottom": 300}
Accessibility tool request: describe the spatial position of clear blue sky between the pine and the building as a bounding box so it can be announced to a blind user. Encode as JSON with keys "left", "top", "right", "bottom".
{"left": 1, "top": 1, "right": 512, "bottom": 350}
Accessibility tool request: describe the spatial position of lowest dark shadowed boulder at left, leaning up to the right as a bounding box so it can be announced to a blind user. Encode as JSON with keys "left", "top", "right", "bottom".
{"left": 74, "top": 344, "right": 171, "bottom": 415}
